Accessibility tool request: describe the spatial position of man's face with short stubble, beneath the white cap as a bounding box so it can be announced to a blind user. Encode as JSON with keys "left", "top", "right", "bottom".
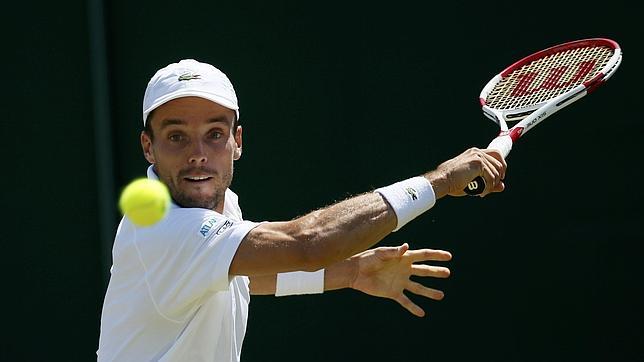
{"left": 141, "top": 97, "right": 242, "bottom": 213}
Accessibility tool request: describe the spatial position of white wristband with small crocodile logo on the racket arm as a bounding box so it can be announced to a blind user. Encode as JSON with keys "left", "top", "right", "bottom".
{"left": 375, "top": 176, "right": 436, "bottom": 231}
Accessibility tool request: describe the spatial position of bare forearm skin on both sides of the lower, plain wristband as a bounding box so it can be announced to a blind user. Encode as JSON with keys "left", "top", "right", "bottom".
{"left": 250, "top": 258, "right": 358, "bottom": 295}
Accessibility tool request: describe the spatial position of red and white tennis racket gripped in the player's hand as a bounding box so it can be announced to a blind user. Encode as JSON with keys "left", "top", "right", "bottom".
{"left": 463, "top": 38, "right": 622, "bottom": 195}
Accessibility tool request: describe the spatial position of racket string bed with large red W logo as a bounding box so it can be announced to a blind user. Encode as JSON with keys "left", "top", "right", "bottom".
{"left": 486, "top": 47, "right": 614, "bottom": 109}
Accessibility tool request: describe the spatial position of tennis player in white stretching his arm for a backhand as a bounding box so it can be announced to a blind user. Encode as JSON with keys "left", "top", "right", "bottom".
{"left": 97, "top": 60, "right": 506, "bottom": 361}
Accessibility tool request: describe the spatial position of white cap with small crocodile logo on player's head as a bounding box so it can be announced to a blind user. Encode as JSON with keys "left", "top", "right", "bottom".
{"left": 143, "top": 59, "right": 239, "bottom": 127}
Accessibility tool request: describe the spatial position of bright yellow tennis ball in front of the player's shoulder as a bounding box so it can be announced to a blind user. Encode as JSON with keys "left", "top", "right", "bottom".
{"left": 119, "top": 178, "right": 170, "bottom": 226}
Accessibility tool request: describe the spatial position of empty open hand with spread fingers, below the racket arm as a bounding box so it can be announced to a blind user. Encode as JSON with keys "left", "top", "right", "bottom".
{"left": 351, "top": 243, "right": 452, "bottom": 317}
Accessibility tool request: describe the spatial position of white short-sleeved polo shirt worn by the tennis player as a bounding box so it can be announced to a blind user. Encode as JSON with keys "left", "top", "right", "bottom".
{"left": 96, "top": 168, "right": 257, "bottom": 362}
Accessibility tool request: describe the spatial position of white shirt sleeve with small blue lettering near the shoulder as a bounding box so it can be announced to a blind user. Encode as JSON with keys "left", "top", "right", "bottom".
{"left": 137, "top": 208, "right": 257, "bottom": 318}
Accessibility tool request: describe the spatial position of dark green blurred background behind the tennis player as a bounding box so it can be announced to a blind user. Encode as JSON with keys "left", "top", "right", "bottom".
{"left": 0, "top": 0, "right": 644, "bottom": 361}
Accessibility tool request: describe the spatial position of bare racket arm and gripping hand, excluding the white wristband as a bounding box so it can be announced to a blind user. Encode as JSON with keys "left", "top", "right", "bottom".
{"left": 229, "top": 149, "right": 505, "bottom": 276}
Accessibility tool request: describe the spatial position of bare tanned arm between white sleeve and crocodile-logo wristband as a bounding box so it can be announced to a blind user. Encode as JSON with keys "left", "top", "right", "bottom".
{"left": 230, "top": 193, "right": 396, "bottom": 276}
